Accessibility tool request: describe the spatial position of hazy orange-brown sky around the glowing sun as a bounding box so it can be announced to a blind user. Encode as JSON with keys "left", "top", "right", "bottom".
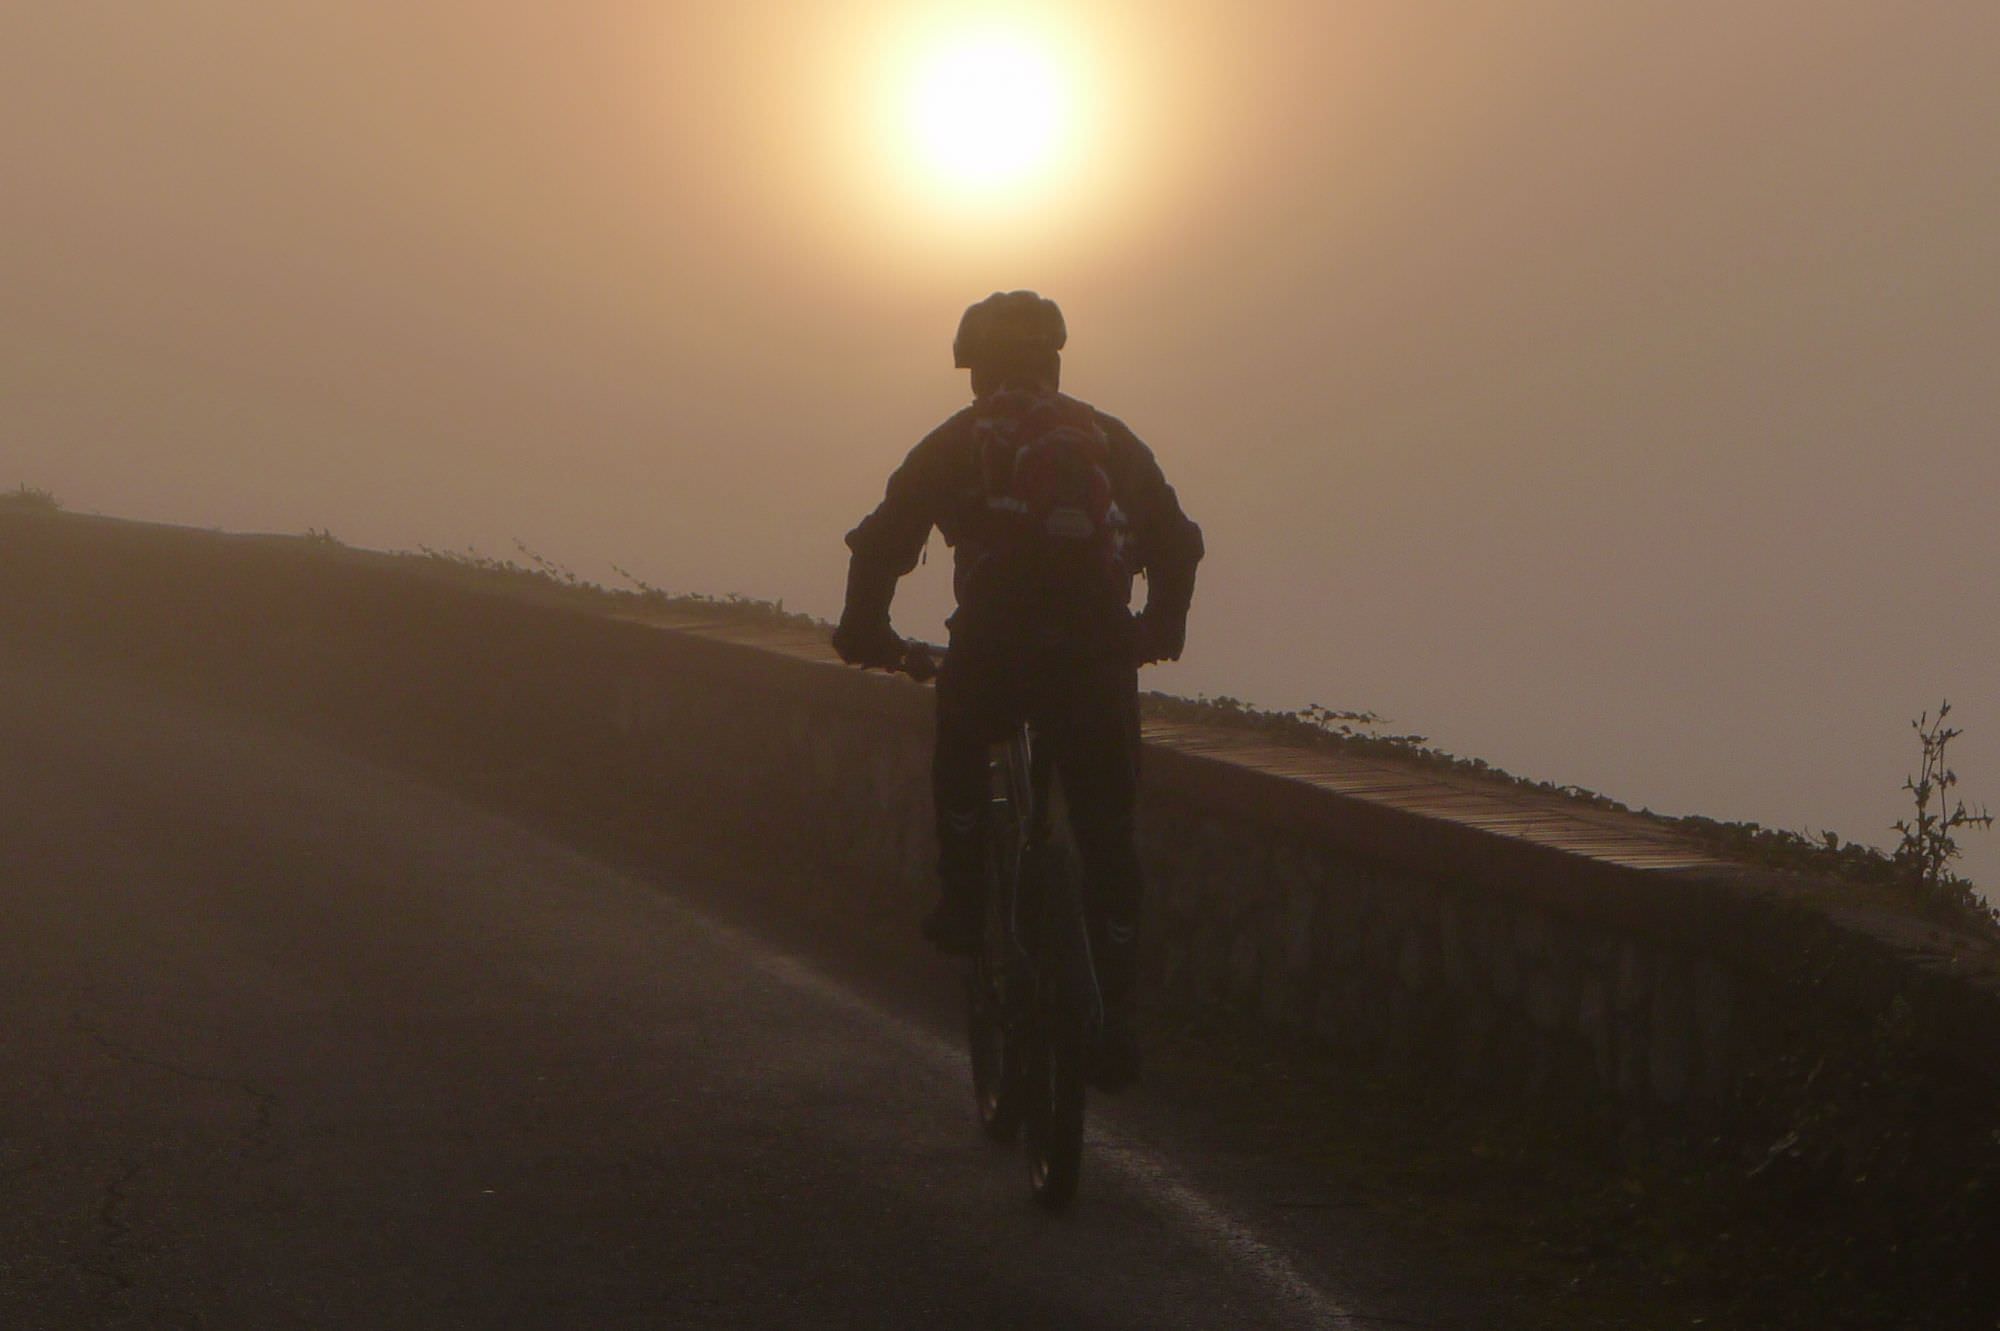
{"left": 0, "top": 0, "right": 2000, "bottom": 885}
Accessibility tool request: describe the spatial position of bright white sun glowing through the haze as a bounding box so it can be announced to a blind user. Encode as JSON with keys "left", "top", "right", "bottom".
{"left": 902, "top": 28, "right": 1078, "bottom": 198}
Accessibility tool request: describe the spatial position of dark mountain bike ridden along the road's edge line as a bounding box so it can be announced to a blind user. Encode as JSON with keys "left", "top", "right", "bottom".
{"left": 904, "top": 646, "right": 1104, "bottom": 1211}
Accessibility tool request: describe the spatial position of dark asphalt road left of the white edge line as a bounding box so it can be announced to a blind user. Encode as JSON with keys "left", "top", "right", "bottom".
{"left": 0, "top": 664, "right": 1376, "bottom": 1331}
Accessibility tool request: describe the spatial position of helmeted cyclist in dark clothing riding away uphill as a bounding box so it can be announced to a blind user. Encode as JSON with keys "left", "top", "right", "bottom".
{"left": 834, "top": 292, "right": 1202, "bottom": 1089}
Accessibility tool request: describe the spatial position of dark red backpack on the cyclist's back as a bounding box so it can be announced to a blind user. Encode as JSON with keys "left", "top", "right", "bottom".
{"left": 972, "top": 390, "right": 1130, "bottom": 590}
